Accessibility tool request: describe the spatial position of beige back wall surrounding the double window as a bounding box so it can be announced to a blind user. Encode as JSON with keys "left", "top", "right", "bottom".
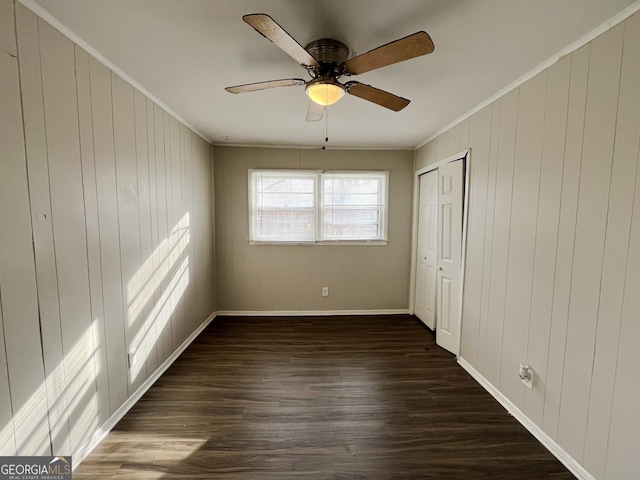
{"left": 214, "top": 147, "right": 413, "bottom": 312}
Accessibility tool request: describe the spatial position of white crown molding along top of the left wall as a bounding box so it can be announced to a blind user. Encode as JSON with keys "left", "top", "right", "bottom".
{"left": 18, "top": 0, "right": 211, "bottom": 144}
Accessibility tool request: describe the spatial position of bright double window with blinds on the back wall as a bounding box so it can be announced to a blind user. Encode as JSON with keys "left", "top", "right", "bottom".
{"left": 249, "top": 170, "right": 389, "bottom": 243}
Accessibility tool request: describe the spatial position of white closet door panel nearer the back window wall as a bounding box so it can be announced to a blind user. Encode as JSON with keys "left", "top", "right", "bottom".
{"left": 414, "top": 170, "right": 438, "bottom": 330}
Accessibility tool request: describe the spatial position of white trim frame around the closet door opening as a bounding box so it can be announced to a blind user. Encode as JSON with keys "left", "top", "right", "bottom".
{"left": 409, "top": 148, "right": 471, "bottom": 346}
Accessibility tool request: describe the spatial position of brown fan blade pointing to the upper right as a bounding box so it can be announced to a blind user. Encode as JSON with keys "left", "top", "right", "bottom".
{"left": 344, "top": 32, "right": 435, "bottom": 75}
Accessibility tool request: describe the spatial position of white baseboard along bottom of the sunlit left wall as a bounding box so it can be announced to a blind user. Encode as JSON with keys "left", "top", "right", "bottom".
{"left": 73, "top": 313, "right": 217, "bottom": 470}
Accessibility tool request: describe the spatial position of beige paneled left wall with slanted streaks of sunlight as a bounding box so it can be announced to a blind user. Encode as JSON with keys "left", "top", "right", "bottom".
{"left": 0, "top": 0, "right": 215, "bottom": 455}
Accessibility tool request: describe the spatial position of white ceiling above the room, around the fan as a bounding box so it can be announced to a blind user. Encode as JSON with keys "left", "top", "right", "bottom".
{"left": 28, "top": 0, "right": 635, "bottom": 148}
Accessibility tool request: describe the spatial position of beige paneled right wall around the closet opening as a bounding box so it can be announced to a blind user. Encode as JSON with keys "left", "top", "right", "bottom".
{"left": 415, "top": 14, "right": 640, "bottom": 480}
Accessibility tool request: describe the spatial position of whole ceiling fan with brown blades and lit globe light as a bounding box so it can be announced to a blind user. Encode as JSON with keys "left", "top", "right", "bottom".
{"left": 225, "top": 13, "right": 434, "bottom": 122}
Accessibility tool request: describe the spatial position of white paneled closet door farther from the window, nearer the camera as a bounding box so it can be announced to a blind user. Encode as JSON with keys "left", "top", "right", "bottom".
{"left": 436, "top": 161, "right": 464, "bottom": 355}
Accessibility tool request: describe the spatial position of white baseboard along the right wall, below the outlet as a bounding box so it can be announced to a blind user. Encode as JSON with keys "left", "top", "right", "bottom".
{"left": 458, "top": 357, "right": 596, "bottom": 480}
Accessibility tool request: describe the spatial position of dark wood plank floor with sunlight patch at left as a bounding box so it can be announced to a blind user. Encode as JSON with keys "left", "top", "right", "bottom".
{"left": 73, "top": 315, "right": 575, "bottom": 480}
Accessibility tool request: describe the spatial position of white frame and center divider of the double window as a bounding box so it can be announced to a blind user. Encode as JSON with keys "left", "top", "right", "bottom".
{"left": 248, "top": 169, "right": 389, "bottom": 245}
